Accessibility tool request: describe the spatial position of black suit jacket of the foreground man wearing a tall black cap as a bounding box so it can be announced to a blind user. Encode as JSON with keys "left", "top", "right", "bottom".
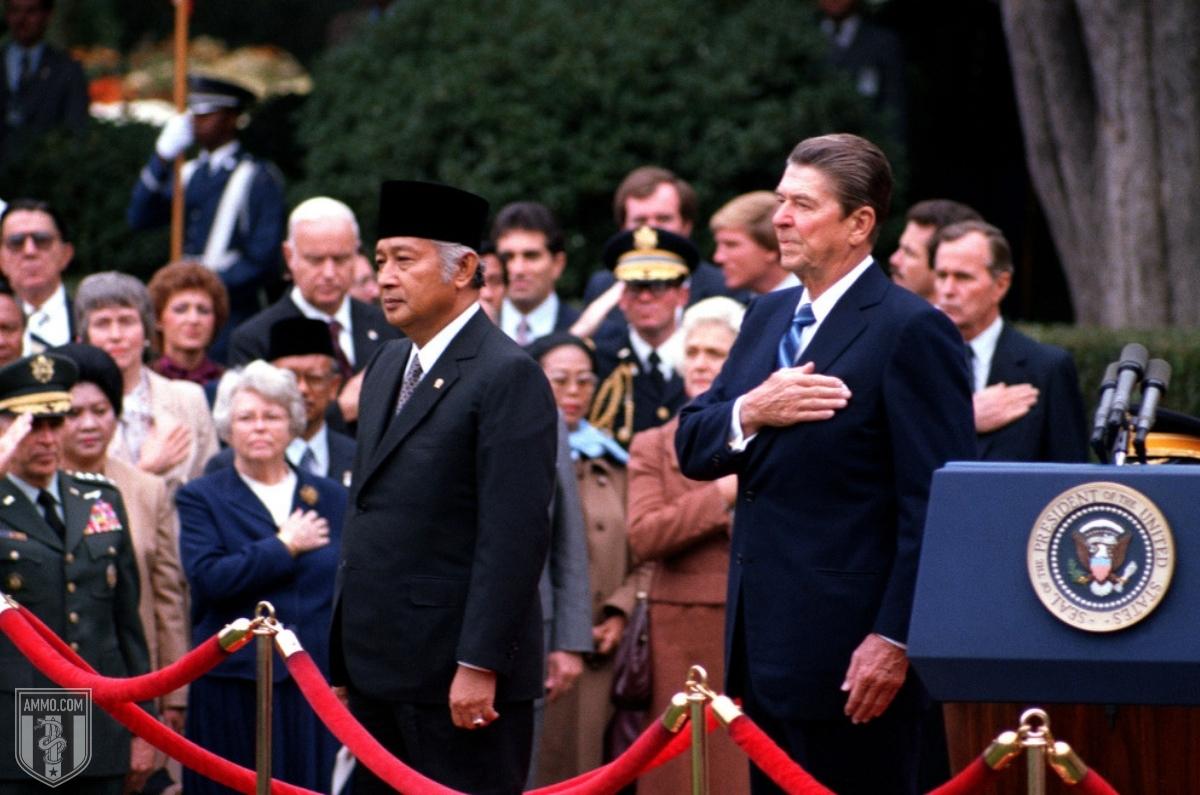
{"left": 332, "top": 311, "right": 557, "bottom": 713}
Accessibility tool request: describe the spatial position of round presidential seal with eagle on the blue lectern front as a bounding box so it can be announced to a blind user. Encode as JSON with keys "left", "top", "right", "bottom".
{"left": 1027, "top": 482, "right": 1175, "bottom": 632}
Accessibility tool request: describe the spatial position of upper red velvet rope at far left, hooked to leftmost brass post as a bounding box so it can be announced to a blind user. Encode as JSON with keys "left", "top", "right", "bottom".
{"left": 0, "top": 610, "right": 227, "bottom": 704}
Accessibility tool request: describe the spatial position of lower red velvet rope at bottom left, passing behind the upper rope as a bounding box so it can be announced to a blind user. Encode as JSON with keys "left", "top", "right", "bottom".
{"left": 8, "top": 606, "right": 318, "bottom": 795}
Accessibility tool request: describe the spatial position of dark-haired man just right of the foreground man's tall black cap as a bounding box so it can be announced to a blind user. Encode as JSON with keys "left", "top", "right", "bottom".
{"left": 491, "top": 202, "right": 580, "bottom": 346}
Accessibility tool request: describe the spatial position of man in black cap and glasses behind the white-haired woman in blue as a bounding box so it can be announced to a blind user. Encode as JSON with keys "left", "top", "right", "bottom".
{"left": 204, "top": 317, "right": 354, "bottom": 489}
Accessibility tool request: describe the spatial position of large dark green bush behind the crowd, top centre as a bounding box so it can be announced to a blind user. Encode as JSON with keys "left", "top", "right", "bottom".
{"left": 292, "top": 0, "right": 878, "bottom": 292}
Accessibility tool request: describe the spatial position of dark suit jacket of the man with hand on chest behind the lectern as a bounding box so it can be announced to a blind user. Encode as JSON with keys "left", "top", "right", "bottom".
{"left": 979, "top": 322, "right": 1088, "bottom": 464}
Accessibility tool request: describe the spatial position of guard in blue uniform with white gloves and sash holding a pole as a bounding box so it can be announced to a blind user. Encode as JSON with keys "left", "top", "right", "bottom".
{"left": 127, "top": 74, "right": 286, "bottom": 361}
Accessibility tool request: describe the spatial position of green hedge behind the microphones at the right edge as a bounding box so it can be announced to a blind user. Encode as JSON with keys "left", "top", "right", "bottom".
{"left": 1020, "top": 324, "right": 1200, "bottom": 422}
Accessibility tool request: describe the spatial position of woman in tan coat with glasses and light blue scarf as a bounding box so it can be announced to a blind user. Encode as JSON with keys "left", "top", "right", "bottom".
{"left": 529, "top": 333, "right": 648, "bottom": 784}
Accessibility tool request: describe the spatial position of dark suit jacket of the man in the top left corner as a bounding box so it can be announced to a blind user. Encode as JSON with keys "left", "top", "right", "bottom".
{"left": 0, "top": 44, "right": 88, "bottom": 160}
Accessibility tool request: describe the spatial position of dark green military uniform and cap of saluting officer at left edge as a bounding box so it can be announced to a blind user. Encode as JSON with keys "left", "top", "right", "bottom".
{"left": 0, "top": 355, "right": 150, "bottom": 793}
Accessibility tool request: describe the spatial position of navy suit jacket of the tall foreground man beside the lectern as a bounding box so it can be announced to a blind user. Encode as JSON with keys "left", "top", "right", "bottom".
{"left": 676, "top": 268, "right": 974, "bottom": 719}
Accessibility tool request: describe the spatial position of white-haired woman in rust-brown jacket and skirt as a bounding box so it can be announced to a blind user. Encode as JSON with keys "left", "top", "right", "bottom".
{"left": 629, "top": 298, "right": 750, "bottom": 795}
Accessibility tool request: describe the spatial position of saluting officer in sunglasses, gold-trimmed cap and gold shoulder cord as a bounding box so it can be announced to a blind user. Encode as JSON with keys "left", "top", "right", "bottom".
{"left": 588, "top": 226, "right": 700, "bottom": 448}
